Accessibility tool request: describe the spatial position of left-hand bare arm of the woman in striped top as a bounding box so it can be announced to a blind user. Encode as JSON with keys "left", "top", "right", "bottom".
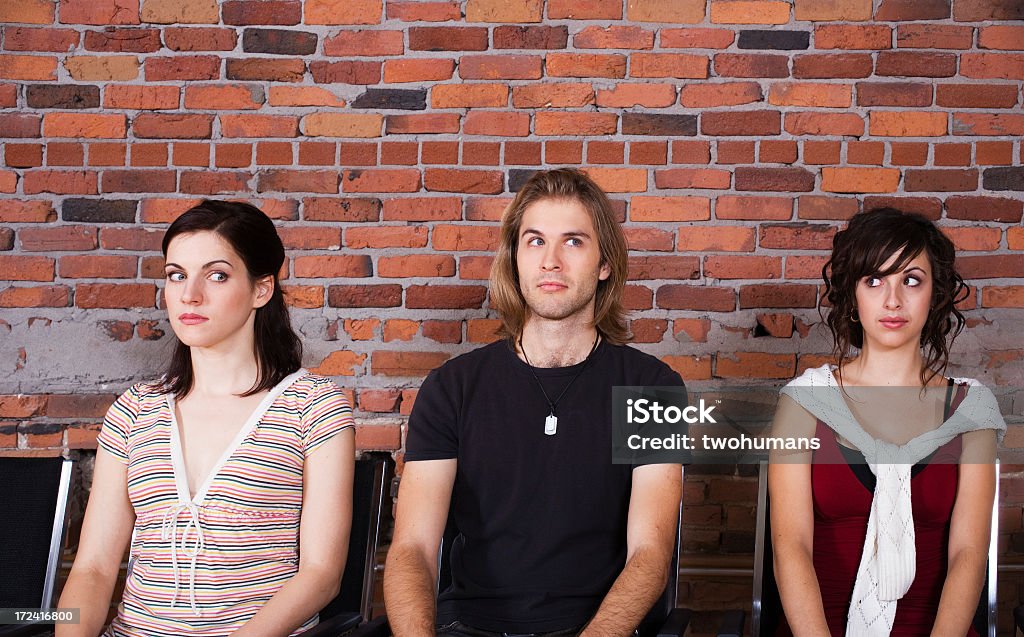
{"left": 56, "top": 448, "right": 135, "bottom": 637}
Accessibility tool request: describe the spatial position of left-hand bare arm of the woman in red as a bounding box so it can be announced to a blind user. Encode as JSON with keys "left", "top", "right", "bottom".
{"left": 768, "top": 395, "right": 829, "bottom": 637}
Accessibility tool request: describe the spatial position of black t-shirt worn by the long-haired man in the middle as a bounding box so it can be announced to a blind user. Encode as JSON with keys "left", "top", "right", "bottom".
{"left": 406, "top": 340, "right": 682, "bottom": 633}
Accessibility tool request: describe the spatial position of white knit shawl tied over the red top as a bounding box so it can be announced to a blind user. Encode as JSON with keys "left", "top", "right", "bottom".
{"left": 782, "top": 365, "right": 1007, "bottom": 637}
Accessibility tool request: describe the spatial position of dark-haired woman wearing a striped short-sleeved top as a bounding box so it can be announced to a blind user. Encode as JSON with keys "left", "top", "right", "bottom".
{"left": 57, "top": 201, "right": 354, "bottom": 637}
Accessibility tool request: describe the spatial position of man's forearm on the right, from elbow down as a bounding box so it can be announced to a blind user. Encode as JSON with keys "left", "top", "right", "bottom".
{"left": 581, "top": 548, "right": 671, "bottom": 637}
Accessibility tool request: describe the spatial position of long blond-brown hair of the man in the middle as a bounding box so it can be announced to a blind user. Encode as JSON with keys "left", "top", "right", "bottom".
{"left": 490, "top": 168, "right": 632, "bottom": 345}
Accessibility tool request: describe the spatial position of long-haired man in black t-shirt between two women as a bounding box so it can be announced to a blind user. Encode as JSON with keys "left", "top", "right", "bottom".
{"left": 384, "top": 169, "right": 682, "bottom": 637}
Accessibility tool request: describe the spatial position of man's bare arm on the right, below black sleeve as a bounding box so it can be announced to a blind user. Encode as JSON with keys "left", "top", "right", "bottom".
{"left": 582, "top": 464, "right": 683, "bottom": 637}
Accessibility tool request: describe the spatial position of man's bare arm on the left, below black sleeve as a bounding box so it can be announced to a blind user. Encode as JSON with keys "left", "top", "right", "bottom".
{"left": 384, "top": 459, "right": 456, "bottom": 637}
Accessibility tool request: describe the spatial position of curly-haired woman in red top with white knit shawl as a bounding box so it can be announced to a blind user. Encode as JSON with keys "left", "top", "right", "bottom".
{"left": 768, "top": 208, "right": 1006, "bottom": 637}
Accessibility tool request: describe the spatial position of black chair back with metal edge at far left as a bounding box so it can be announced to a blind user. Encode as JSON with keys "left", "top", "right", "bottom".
{"left": 0, "top": 457, "right": 74, "bottom": 608}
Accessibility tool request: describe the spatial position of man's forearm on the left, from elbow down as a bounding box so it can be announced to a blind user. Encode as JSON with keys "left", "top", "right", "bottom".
{"left": 384, "top": 547, "right": 436, "bottom": 637}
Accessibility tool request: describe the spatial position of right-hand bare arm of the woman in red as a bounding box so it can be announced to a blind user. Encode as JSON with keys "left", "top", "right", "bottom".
{"left": 932, "top": 429, "right": 995, "bottom": 637}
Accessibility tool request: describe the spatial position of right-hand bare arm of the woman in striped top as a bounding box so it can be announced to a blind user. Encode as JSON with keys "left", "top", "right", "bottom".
{"left": 233, "top": 428, "right": 355, "bottom": 637}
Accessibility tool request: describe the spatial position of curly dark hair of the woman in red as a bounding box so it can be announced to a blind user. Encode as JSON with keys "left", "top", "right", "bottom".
{"left": 818, "top": 208, "right": 969, "bottom": 385}
